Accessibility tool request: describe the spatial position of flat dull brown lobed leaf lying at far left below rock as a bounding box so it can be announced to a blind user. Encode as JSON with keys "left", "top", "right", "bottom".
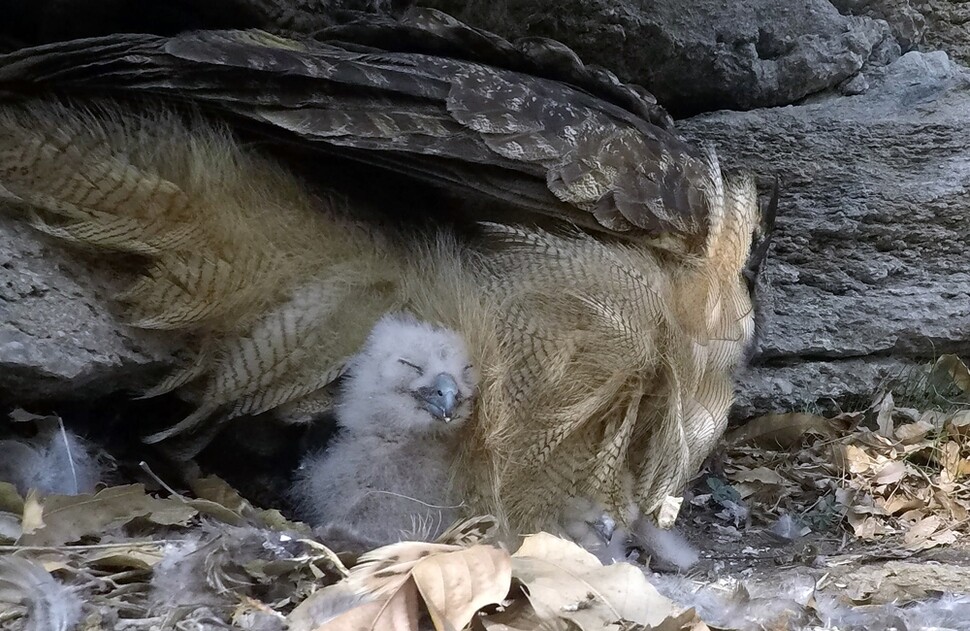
{"left": 19, "top": 484, "right": 196, "bottom": 546}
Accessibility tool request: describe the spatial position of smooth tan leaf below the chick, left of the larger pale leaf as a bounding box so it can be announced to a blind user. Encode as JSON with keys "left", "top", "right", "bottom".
{"left": 411, "top": 545, "right": 512, "bottom": 631}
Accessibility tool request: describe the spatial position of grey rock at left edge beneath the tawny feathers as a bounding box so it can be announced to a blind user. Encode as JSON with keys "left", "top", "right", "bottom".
{"left": 0, "top": 214, "right": 172, "bottom": 404}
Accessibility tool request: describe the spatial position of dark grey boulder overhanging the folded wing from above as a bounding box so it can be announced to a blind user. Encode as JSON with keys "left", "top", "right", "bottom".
{"left": 422, "top": 0, "right": 899, "bottom": 115}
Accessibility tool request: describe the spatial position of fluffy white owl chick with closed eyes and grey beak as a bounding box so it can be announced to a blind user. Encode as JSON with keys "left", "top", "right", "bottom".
{"left": 293, "top": 314, "right": 477, "bottom": 550}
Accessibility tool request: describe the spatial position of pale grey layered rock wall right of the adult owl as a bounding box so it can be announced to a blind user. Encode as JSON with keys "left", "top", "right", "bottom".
{"left": 680, "top": 52, "right": 970, "bottom": 416}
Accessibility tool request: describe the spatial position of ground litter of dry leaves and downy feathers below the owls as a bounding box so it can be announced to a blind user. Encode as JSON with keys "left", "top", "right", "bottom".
{"left": 0, "top": 356, "right": 970, "bottom": 631}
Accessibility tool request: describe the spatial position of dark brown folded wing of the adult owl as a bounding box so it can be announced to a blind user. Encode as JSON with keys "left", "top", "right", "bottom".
{"left": 0, "top": 11, "right": 709, "bottom": 240}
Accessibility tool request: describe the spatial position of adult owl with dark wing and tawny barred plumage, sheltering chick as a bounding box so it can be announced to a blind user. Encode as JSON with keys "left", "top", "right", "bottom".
{"left": 0, "top": 4, "right": 767, "bottom": 532}
